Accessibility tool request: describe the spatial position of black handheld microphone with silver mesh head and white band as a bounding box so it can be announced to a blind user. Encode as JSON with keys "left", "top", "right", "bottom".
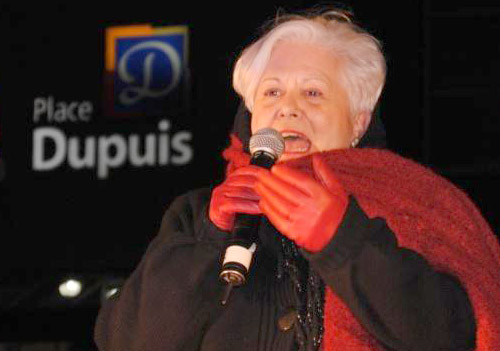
{"left": 219, "top": 128, "right": 285, "bottom": 305}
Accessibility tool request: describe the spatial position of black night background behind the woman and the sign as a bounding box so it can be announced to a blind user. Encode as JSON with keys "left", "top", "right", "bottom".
{"left": 0, "top": 0, "right": 500, "bottom": 348}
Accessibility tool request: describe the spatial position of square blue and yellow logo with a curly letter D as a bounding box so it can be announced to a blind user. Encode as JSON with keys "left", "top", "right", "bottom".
{"left": 105, "top": 25, "right": 188, "bottom": 116}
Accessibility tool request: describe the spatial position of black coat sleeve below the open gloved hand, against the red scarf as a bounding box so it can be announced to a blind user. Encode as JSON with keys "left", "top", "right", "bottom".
{"left": 304, "top": 197, "right": 476, "bottom": 351}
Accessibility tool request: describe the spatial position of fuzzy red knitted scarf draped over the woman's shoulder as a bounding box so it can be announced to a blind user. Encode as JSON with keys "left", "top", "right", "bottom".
{"left": 223, "top": 136, "right": 500, "bottom": 351}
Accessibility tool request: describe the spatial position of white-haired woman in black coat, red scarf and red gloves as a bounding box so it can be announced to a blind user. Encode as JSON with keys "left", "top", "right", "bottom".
{"left": 96, "top": 8, "right": 500, "bottom": 351}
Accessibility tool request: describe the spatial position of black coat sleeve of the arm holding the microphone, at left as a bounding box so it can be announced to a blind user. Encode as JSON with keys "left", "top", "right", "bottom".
{"left": 94, "top": 191, "right": 227, "bottom": 351}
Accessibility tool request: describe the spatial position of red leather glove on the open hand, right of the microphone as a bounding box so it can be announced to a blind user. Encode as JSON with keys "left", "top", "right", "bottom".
{"left": 255, "top": 155, "right": 348, "bottom": 252}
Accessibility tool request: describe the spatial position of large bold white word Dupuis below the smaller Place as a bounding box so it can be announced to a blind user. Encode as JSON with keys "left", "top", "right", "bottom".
{"left": 32, "top": 121, "right": 193, "bottom": 179}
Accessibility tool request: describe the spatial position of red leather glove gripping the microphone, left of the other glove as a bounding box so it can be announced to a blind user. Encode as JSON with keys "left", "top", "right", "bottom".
{"left": 208, "top": 166, "right": 265, "bottom": 232}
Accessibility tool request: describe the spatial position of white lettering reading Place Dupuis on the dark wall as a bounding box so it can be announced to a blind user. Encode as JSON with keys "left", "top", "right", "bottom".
{"left": 31, "top": 96, "right": 193, "bottom": 179}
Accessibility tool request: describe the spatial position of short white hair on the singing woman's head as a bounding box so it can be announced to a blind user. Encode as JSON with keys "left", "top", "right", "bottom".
{"left": 233, "top": 11, "right": 386, "bottom": 116}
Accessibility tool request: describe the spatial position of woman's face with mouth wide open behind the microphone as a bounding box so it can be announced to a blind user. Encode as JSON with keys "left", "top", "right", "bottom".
{"left": 251, "top": 42, "right": 362, "bottom": 161}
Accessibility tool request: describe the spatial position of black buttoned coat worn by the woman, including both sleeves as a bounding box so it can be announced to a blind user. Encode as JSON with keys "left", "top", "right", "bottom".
{"left": 95, "top": 189, "right": 476, "bottom": 351}
